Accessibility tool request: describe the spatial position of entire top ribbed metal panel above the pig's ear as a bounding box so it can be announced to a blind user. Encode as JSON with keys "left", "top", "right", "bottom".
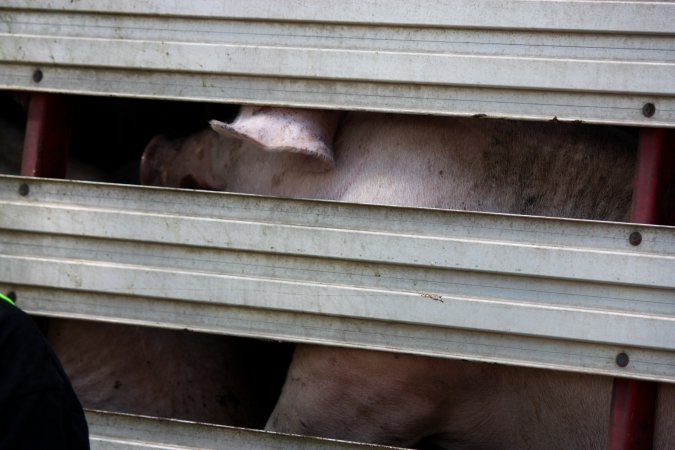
{"left": 0, "top": 0, "right": 675, "bottom": 126}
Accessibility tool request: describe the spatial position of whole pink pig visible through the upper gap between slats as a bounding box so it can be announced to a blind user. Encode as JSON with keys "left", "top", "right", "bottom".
{"left": 141, "top": 107, "right": 635, "bottom": 221}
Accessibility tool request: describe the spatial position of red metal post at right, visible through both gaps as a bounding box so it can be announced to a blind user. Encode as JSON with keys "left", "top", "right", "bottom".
{"left": 608, "top": 128, "right": 675, "bottom": 450}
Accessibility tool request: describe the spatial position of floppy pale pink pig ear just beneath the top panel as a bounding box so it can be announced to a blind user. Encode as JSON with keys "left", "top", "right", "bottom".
{"left": 210, "top": 106, "right": 343, "bottom": 169}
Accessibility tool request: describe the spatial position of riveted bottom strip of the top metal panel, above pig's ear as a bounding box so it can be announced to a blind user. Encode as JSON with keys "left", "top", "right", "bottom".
{"left": 0, "top": 63, "right": 675, "bottom": 127}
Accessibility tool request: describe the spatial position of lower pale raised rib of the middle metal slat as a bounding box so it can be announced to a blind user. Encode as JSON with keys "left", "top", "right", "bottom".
{"left": 5, "top": 256, "right": 675, "bottom": 350}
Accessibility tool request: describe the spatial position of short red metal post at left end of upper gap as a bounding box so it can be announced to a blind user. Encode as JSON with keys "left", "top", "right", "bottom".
{"left": 21, "top": 92, "right": 71, "bottom": 178}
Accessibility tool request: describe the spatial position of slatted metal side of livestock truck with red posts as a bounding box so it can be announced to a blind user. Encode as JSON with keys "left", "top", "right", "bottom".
{"left": 0, "top": 0, "right": 675, "bottom": 449}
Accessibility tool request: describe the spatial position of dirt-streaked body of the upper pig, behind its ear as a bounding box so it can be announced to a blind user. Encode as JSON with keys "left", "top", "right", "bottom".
{"left": 327, "top": 113, "right": 636, "bottom": 221}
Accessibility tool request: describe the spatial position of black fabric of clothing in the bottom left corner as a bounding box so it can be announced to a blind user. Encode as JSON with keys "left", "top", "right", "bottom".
{"left": 0, "top": 299, "right": 89, "bottom": 450}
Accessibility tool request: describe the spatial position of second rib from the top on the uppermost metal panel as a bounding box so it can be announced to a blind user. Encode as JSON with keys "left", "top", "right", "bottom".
{"left": 6, "top": 10, "right": 675, "bottom": 62}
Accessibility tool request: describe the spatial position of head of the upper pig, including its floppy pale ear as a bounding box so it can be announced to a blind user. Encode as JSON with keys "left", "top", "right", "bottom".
{"left": 141, "top": 107, "right": 343, "bottom": 193}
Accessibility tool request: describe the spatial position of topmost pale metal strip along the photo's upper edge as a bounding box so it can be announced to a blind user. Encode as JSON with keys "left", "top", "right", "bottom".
{"left": 4, "top": 0, "right": 675, "bottom": 34}
